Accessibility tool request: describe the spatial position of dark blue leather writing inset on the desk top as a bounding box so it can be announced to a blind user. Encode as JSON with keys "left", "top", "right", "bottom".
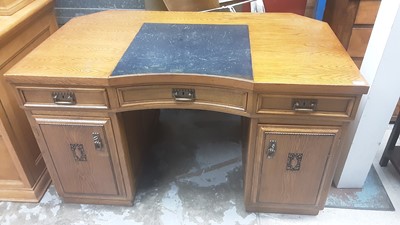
{"left": 112, "top": 23, "right": 253, "bottom": 80}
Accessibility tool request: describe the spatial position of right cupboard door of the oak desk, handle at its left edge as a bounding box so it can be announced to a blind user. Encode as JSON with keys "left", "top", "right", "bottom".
{"left": 255, "top": 125, "right": 338, "bottom": 205}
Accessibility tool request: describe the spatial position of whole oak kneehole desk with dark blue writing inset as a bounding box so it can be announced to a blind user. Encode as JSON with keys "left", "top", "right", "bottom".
{"left": 6, "top": 11, "right": 368, "bottom": 214}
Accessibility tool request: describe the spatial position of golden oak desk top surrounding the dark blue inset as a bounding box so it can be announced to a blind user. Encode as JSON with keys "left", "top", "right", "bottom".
{"left": 6, "top": 11, "right": 368, "bottom": 94}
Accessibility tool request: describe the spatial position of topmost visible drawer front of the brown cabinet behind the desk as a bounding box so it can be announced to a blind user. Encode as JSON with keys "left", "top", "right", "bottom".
{"left": 354, "top": 0, "right": 381, "bottom": 24}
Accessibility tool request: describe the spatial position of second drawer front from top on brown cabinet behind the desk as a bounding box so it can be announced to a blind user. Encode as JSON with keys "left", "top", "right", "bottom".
{"left": 347, "top": 28, "right": 372, "bottom": 57}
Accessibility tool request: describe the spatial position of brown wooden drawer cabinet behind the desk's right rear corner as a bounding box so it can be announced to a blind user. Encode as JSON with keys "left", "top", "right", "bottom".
{"left": 324, "top": 0, "right": 381, "bottom": 68}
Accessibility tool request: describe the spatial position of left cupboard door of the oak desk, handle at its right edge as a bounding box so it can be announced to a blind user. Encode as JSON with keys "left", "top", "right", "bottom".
{"left": 36, "top": 118, "right": 122, "bottom": 198}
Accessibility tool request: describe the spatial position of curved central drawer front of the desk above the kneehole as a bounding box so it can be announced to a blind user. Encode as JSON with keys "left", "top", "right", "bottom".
{"left": 118, "top": 85, "right": 247, "bottom": 111}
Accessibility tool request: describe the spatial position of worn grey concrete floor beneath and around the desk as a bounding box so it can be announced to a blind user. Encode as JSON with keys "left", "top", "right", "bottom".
{"left": 0, "top": 110, "right": 400, "bottom": 225}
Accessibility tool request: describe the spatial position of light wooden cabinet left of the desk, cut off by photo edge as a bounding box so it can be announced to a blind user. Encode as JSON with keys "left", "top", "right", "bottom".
{"left": 0, "top": 0, "right": 57, "bottom": 202}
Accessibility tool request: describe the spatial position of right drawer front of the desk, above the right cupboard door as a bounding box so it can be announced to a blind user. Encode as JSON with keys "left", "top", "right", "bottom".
{"left": 257, "top": 94, "right": 356, "bottom": 118}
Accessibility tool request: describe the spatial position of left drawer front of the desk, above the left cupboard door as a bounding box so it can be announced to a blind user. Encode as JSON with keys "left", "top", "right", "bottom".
{"left": 17, "top": 87, "right": 109, "bottom": 109}
